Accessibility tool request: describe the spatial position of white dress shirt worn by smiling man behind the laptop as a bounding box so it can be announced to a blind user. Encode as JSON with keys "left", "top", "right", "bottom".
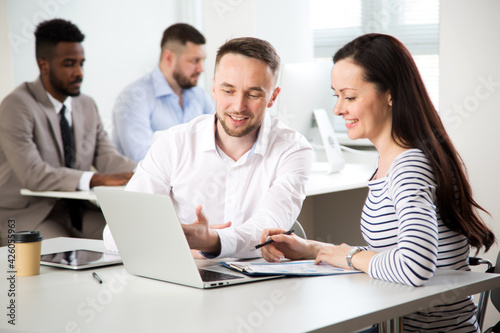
{"left": 104, "top": 113, "right": 314, "bottom": 257}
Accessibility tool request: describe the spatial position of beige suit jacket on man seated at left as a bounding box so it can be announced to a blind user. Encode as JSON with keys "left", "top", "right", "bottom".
{"left": 0, "top": 78, "right": 136, "bottom": 239}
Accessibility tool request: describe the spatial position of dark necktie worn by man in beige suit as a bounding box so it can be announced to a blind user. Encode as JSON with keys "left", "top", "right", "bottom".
{"left": 59, "top": 104, "right": 82, "bottom": 231}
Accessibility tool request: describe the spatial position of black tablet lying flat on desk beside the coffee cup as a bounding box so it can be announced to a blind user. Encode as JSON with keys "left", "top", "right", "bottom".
{"left": 40, "top": 249, "right": 122, "bottom": 269}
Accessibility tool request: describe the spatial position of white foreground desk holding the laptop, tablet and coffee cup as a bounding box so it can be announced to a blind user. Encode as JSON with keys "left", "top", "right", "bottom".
{"left": 0, "top": 238, "right": 500, "bottom": 333}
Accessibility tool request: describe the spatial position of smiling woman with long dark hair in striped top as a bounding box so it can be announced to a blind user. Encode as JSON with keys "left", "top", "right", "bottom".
{"left": 262, "top": 34, "right": 495, "bottom": 332}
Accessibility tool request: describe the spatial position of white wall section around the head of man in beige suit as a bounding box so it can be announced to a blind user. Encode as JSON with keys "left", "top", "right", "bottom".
{"left": 4, "top": 0, "right": 178, "bottom": 129}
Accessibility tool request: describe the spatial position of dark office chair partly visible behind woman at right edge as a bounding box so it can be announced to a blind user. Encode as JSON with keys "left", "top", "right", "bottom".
{"left": 469, "top": 252, "right": 500, "bottom": 333}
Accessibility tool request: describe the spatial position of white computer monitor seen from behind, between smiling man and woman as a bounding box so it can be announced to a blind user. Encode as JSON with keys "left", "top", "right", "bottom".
{"left": 276, "top": 61, "right": 345, "bottom": 173}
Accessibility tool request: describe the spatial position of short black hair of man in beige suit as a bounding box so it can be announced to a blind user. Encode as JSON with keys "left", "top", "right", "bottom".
{"left": 35, "top": 19, "right": 85, "bottom": 59}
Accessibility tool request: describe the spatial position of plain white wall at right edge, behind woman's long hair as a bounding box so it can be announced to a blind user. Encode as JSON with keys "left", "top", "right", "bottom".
{"left": 440, "top": 0, "right": 500, "bottom": 327}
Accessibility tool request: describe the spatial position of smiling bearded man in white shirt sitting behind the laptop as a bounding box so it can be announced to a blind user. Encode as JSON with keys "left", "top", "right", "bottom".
{"left": 104, "top": 38, "right": 313, "bottom": 257}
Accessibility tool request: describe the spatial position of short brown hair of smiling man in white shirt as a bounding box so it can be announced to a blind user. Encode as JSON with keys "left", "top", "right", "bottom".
{"left": 215, "top": 37, "right": 281, "bottom": 79}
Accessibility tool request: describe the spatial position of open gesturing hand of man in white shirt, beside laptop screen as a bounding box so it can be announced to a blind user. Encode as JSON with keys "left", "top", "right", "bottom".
{"left": 182, "top": 206, "right": 231, "bottom": 255}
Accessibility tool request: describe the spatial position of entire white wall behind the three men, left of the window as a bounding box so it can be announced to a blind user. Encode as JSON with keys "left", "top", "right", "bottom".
{"left": 0, "top": 0, "right": 313, "bottom": 125}
